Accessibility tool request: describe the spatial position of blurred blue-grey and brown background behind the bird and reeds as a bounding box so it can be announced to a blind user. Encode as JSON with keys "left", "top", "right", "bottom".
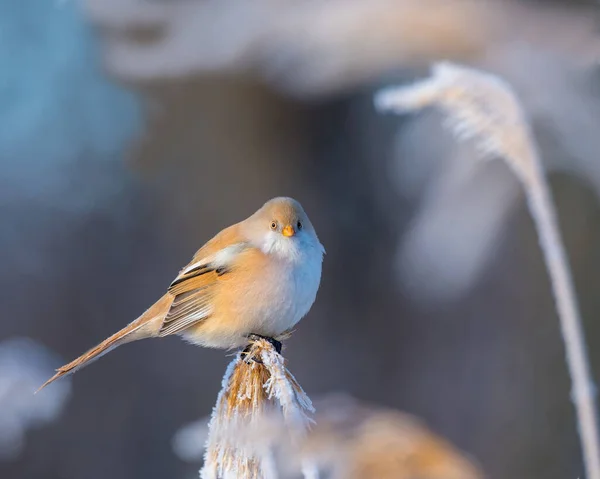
{"left": 0, "top": 0, "right": 600, "bottom": 479}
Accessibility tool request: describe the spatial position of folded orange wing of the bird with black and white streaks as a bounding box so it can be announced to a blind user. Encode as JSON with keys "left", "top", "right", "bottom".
{"left": 158, "top": 227, "right": 250, "bottom": 337}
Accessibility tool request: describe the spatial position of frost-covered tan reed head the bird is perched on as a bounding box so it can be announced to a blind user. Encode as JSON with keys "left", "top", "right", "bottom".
{"left": 200, "top": 339, "right": 316, "bottom": 479}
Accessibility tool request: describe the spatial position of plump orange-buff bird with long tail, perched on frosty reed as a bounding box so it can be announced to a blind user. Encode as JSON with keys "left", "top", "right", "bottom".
{"left": 38, "top": 197, "right": 325, "bottom": 391}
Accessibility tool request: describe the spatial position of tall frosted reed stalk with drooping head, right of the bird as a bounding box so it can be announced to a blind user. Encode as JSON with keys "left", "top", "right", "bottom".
{"left": 375, "top": 63, "right": 600, "bottom": 479}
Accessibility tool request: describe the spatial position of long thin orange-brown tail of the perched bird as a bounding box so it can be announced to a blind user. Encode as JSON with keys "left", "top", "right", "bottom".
{"left": 36, "top": 293, "right": 173, "bottom": 394}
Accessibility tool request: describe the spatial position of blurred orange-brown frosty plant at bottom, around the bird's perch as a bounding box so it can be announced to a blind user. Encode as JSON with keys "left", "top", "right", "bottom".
{"left": 173, "top": 394, "right": 484, "bottom": 479}
